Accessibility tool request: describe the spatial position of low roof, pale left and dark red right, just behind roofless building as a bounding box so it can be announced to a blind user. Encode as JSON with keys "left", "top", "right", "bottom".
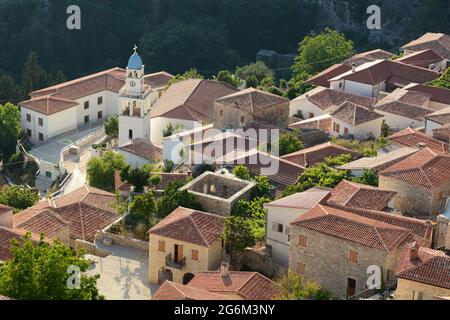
{"left": 215, "top": 150, "right": 305, "bottom": 186}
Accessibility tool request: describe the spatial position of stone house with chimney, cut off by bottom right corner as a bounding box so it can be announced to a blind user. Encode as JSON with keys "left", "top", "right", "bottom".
{"left": 394, "top": 243, "right": 450, "bottom": 300}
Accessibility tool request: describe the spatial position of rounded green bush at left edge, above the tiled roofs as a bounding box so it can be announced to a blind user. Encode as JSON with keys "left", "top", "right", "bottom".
{"left": 0, "top": 186, "right": 39, "bottom": 211}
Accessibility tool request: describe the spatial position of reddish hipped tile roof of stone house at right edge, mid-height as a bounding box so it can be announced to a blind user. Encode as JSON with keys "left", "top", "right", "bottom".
{"left": 379, "top": 148, "right": 450, "bottom": 188}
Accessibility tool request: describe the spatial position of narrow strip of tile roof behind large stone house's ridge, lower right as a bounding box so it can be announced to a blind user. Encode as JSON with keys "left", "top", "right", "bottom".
{"left": 327, "top": 202, "right": 433, "bottom": 240}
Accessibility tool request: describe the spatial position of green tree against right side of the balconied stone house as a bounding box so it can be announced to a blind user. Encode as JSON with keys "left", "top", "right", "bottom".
{"left": 222, "top": 216, "right": 255, "bottom": 263}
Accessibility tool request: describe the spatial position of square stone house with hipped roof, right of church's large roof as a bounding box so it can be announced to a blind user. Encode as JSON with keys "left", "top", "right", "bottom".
{"left": 214, "top": 88, "right": 289, "bottom": 129}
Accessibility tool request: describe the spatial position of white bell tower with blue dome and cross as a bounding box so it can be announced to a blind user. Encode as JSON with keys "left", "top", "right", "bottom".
{"left": 118, "top": 46, "right": 151, "bottom": 146}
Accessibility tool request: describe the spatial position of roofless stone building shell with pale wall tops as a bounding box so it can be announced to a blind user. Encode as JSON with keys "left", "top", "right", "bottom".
{"left": 180, "top": 171, "right": 256, "bottom": 216}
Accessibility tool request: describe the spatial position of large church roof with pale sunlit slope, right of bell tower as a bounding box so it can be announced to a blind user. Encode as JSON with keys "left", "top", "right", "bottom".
{"left": 150, "top": 79, "right": 238, "bottom": 122}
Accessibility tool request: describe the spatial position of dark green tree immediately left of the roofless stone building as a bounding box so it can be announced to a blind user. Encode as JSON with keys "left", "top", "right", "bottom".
{"left": 158, "top": 181, "right": 203, "bottom": 219}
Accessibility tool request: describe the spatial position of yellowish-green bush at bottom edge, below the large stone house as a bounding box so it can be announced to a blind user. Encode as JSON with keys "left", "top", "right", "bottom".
{"left": 276, "top": 270, "right": 331, "bottom": 300}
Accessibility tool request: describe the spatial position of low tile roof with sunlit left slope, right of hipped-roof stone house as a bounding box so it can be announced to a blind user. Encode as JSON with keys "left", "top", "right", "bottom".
{"left": 294, "top": 87, "right": 377, "bottom": 110}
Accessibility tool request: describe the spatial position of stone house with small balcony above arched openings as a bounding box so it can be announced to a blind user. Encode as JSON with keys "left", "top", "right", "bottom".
{"left": 148, "top": 207, "right": 225, "bottom": 284}
